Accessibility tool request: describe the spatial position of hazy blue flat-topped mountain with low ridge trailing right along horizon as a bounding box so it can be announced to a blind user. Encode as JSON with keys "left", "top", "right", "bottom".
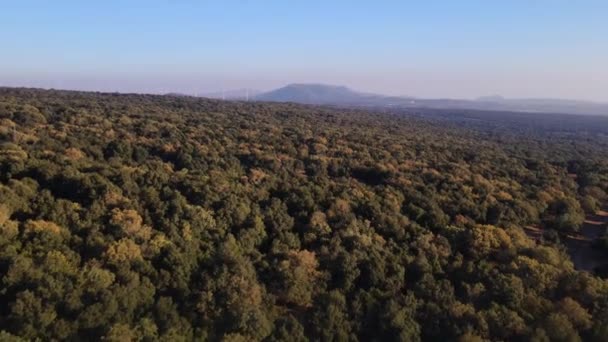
{"left": 254, "top": 84, "right": 608, "bottom": 115}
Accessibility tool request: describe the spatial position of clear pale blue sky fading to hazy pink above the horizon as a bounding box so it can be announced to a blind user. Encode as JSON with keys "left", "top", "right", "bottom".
{"left": 0, "top": 0, "right": 608, "bottom": 102}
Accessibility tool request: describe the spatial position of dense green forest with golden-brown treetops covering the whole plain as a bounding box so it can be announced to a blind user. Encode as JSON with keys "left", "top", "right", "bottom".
{"left": 0, "top": 88, "right": 608, "bottom": 342}
